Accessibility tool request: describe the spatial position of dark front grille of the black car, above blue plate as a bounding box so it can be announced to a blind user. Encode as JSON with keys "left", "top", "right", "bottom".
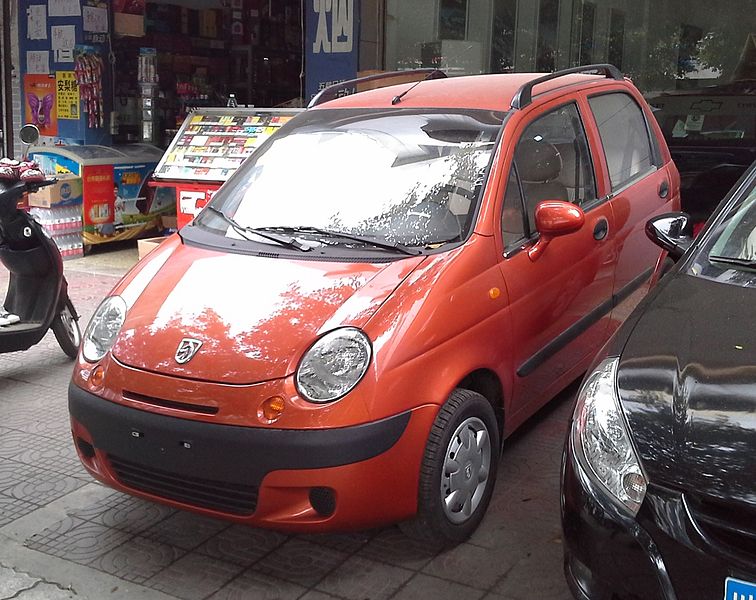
{"left": 685, "top": 494, "right": 756, "bottom": 562}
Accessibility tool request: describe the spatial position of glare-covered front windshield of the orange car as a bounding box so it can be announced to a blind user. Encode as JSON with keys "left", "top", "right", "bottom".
{"left": 195, "top": 109, "right": 505, "bottom": 251}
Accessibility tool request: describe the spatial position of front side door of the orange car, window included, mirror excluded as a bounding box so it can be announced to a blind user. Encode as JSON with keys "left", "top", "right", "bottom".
{"left": 499, "top": 101, "right": 614, "bottom": 427}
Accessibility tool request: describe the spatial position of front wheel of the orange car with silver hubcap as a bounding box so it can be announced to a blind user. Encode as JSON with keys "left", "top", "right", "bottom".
{"left": 399, "top": 389, "right": 500, "bottom": 545}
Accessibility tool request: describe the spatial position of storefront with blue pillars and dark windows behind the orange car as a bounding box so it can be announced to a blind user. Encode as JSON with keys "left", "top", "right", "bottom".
{"left": 14, "top": 0, "right": 756, "bottom": 148}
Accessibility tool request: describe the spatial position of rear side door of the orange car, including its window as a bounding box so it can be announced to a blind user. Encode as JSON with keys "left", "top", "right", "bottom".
{"left": 587, "top": 90, "right": 677, "bottom": 328}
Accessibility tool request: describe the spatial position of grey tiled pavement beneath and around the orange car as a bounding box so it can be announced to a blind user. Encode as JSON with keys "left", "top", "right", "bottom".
{"left": 0, "top": 244, "right": 574, "bottom": 600}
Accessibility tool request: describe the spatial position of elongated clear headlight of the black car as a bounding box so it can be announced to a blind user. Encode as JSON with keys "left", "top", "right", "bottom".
{"left": 571, "top": 358, "right": 647, "bottom": 516}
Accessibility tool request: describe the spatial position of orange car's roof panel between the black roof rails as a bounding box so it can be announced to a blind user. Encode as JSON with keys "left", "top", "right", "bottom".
{"left": 314, "top": 73, "right": 617, "bottom": 111}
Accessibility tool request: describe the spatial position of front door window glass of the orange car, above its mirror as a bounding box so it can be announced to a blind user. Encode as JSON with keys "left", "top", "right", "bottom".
{"left": 515, "top": 104, "right": 596, "bottom": 231}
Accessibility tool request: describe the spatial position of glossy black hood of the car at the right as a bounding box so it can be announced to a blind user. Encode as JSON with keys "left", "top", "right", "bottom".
{"left": 618, "top": 274, "right": 756, "bottom": 505}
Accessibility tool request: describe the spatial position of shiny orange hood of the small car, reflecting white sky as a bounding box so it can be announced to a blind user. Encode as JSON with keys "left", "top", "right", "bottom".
{"left": 112, "top": 245, "right": 422, "bottom": 384}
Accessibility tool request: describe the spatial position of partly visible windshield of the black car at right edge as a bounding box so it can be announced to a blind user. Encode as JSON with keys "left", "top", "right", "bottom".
{"left": 691, "top": 177, "right": 756, "bottom": 286}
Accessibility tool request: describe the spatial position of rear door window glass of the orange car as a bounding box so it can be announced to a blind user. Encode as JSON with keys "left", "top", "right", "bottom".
{"left": 588, "top": 92, "right": 654, "bottom": 190}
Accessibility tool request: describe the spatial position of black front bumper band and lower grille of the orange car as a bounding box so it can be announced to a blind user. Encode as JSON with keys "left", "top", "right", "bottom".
{"left": 68, "top": 383, "right": 411, "bottom": 514}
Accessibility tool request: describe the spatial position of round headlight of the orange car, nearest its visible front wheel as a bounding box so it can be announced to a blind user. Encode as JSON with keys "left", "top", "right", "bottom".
{"left": 296, "top": 327, "right": 372, "bottom": 402}
